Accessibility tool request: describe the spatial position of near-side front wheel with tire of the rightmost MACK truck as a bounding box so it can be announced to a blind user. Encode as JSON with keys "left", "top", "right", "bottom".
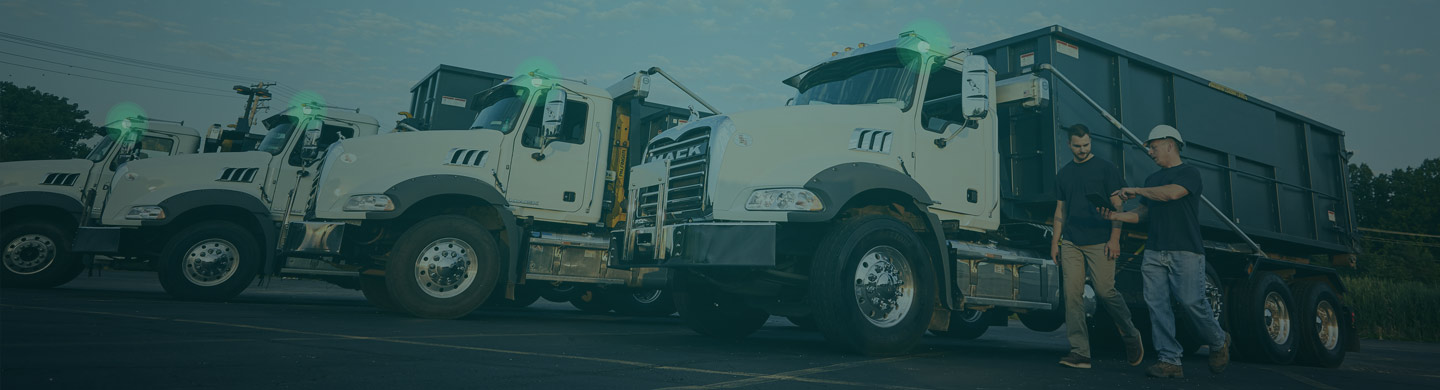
{"left": 809, "top": 216, "right": 936, "bottom": 355}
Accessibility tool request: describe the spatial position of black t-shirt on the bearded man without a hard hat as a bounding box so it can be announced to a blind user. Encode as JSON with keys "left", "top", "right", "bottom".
{"left": 1056, "top": 157, "right": 1125, "bottom": 245}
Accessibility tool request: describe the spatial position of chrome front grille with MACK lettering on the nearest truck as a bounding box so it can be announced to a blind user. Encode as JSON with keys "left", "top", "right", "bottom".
{"left": 636, "top": 127, "right": 710, "bottom": 226}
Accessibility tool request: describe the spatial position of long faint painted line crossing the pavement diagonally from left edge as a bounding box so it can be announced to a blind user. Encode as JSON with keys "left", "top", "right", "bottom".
{"left": 0, "top": 304, "right": 933, "bottom": 389}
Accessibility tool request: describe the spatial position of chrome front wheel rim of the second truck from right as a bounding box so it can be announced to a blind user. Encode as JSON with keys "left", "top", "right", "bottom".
{"left": 415, "top": 237, "right": 480, "bottom": 298}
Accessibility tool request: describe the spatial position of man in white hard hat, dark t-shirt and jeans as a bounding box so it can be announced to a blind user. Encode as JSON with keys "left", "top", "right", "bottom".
{"left": 1102, "top": 125, "right": 1230, "bottom": 378}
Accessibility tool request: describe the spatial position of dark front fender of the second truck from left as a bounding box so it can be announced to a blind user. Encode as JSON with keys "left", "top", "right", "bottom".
{"left": 151, "top": 190, "right": 279, "bottom": 275}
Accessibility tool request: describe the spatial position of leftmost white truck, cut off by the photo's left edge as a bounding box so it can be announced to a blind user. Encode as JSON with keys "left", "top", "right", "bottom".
{"left": 0, "top": 117, "right": 200, "bottom": 288}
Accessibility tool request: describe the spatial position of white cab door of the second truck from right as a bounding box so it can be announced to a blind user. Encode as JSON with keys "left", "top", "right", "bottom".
{"left": 505, "top": 94, "right": 600, "bottom": 213}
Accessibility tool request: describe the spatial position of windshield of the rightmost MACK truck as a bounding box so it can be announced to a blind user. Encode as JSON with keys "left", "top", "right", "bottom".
{"left": 795, "top": 50, "right": 919, "bottom": 109}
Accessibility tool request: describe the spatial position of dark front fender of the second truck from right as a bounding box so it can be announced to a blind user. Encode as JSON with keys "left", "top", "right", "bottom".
{"left": 377, "top": 174, "right": 524, "bottom": 282}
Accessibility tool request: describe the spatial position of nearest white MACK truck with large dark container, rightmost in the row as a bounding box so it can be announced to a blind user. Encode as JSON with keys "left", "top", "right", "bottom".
{"left": 612, "top": 26, "right": 1355, "bottom": 366}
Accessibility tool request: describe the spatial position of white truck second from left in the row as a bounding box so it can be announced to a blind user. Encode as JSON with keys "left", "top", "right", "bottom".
{"left": 76, "top": 104, "right": 379, "bottom": 301}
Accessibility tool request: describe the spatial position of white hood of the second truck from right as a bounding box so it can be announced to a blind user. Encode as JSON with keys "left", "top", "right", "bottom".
{"left": 314, "top": 130, "right": 505, "bottom": 219}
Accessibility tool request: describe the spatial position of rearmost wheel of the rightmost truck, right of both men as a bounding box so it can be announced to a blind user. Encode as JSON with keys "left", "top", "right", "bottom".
{"left": 1293, "top": 281, "right": 1346, "bottom": 368}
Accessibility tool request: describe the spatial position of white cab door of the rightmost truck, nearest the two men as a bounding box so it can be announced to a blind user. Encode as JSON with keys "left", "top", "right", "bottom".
{"left": 913, "top": 62, "right": 996, "bottom": 216}
